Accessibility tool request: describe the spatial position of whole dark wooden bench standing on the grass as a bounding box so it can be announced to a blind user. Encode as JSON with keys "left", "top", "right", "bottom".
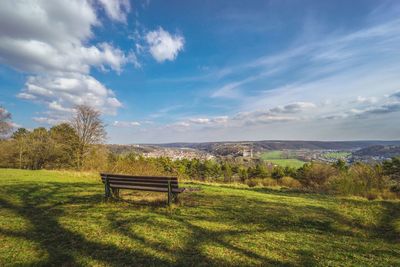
{"left": 100, "top": 173, "right": 185, "bottom": 205}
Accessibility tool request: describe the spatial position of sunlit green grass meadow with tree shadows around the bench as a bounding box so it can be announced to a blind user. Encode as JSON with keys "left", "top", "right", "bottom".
{"left": 0, "top": 169, "right": 400, "bottom": 266}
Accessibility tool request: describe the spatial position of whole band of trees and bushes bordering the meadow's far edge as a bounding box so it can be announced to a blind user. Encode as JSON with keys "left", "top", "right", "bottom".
{"left": 0, "top": 105, "right": 400, "bottom": 198}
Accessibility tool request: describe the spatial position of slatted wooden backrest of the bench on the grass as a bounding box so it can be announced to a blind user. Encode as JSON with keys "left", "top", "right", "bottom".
{"left": 100, "top": 173, "right": 178, "bottom": 192}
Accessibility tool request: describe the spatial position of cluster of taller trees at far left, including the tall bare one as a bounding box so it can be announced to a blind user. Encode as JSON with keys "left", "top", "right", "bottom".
{"left": 0, "top": 105, "right": 106, "bottom": 170}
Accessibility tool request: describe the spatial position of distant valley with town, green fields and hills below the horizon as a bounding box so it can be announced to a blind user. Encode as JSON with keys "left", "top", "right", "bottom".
{"left": 108, "top": 141, "right": 400, "bottom": 166}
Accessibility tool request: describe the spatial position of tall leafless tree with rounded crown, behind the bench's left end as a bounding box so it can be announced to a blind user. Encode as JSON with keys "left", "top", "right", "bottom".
{"left": 71, "top": 105, "right": 106, "bottom": 168}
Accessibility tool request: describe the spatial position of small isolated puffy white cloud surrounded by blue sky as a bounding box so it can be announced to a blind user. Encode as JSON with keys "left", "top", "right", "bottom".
{"left": 145, "top": 27, "right": 185, "bottom": 62}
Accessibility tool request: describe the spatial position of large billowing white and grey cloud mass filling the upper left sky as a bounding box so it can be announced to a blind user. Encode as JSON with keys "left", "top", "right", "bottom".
{"left": 0, "top": 0, "right": 135, "bottom": 123}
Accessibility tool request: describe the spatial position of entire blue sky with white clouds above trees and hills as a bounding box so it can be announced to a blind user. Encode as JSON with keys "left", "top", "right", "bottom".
{"left": 0, "top": 0, "right": 400, "bottom": 143}
